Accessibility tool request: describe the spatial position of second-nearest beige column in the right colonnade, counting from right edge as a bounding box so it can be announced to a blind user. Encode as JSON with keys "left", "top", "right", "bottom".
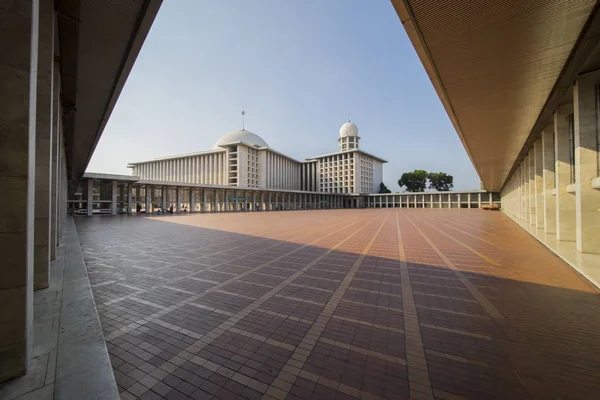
{"left": 554, "top": 107, "right": 576, "bottom": 242}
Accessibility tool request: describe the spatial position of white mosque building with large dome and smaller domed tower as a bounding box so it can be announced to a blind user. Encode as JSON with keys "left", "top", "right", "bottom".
{"left": 128, "top": 121, "right": 387, "bottom": 194}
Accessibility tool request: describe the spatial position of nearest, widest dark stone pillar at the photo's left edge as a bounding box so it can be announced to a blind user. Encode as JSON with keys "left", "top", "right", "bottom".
{"left": 0, "top": 1, "right": 38, "bottom": 382}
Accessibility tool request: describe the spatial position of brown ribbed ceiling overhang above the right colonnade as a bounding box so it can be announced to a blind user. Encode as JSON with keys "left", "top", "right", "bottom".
{"left": 393, "top": 0, "right": 596, "bottom": 191}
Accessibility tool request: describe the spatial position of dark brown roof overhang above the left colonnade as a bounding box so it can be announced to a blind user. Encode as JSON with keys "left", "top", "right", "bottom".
{"left": 55, "top": 0, "right": 162, "bottom": 180}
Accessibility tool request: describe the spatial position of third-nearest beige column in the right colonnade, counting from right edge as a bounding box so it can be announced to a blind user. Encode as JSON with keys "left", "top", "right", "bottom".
{"left": 540, "top": 126, "right": 556, "bottom": 233}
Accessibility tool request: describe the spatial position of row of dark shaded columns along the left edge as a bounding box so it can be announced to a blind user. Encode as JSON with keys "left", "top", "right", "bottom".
{"left": 0, "top": 1, "right": 68, "bottom": 382}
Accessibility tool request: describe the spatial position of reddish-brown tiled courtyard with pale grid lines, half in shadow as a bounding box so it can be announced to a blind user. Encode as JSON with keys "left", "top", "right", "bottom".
{"left": 76, "top": 209, "right": 600, "bottom": 399}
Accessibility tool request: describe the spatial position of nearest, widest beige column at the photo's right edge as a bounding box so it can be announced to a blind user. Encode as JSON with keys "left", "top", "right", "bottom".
{"left": 573, "top": 72, "right": 600, "bottom": 253}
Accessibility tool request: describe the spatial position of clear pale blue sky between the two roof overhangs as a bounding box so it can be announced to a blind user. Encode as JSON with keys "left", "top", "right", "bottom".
{"left": 88, "top": 0, "right": 479, "bottom": 191}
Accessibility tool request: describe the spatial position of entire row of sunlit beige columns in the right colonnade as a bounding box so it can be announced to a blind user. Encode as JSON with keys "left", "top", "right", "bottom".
{"left": 502, "top": 71, "right": 600, "bottom": 253}
